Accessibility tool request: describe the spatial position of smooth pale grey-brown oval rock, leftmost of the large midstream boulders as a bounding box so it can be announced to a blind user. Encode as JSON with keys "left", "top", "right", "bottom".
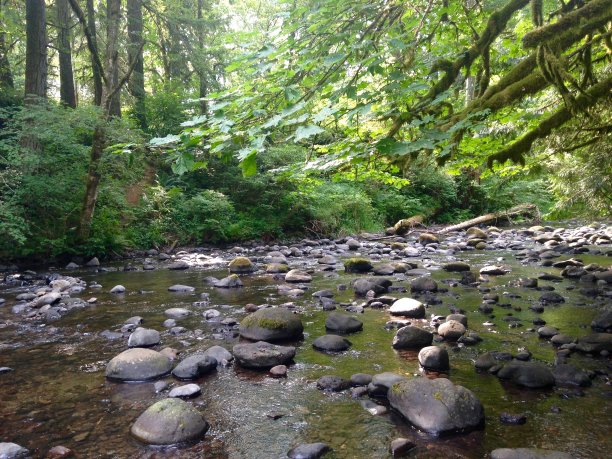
{"left": 106, "top": 348, "right": 172, "bottom": 381}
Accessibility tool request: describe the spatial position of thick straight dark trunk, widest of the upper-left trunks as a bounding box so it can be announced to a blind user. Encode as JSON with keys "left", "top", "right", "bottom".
{"left": 25, "top": 0, "right": 47, "bottom": 103}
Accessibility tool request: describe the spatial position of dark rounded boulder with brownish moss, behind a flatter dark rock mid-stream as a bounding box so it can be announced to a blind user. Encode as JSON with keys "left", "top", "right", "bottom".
{"left": 239, "top": 308, "right": 304, "bottom": 341}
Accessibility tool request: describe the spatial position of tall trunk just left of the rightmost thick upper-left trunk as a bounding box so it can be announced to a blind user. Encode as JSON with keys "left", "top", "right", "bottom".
{"left": 102, "top": 0, "right": 121, "bottom": 117}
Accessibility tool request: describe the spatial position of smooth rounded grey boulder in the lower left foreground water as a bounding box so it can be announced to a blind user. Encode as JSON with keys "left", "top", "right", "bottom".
{"left": 130, "top": 398, "right": 208, "bottom": 445}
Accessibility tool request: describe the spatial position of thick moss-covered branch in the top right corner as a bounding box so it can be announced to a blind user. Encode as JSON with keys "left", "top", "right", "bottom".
{"left": 523, "top": 0, "right": 612, "bottom": 48}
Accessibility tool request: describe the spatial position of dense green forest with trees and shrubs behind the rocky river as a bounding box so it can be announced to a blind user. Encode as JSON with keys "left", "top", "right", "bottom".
{"left": 0, "top": 0, "right": 612, "bottom": 258}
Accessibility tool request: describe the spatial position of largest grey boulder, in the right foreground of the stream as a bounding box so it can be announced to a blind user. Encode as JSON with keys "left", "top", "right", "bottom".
{"left": 388, "top": 378, "right": 484, "bottom": 436}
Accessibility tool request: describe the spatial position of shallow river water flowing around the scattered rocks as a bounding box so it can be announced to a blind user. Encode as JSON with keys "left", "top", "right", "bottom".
{"left": 0, "top": 244, "right": 612, "bottom": 459}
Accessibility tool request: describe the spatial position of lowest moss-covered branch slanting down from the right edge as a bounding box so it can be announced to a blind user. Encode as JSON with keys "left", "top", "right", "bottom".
{"left": 487, "top": 77, "right": 612, "bottom": 167}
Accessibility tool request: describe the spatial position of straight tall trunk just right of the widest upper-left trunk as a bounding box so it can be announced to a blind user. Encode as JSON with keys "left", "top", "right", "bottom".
{"left": 56, "top": 0, "right": 76, "bottom": 108}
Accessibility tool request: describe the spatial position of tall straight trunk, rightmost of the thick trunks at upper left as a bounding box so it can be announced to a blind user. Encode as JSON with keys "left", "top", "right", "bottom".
{"left": 127, "top": 0, "right": 147, "bottom": 129}
